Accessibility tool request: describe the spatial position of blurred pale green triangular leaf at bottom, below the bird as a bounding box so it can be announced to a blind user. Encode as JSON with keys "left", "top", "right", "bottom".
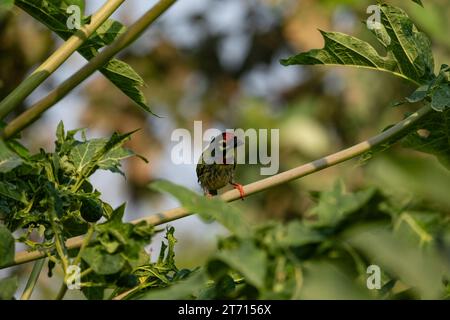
{"left": 214, "top": 241, "right": 268, "bottom": 289}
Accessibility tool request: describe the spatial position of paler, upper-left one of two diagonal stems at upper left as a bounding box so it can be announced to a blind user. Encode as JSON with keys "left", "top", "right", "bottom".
{"left": 0, "top": 0, "right": 125, "bottom": 119}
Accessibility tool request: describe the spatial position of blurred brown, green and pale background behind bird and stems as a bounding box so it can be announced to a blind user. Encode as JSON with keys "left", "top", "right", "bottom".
{"left": 0, "top": 0, "right": 450, "bottom": 297}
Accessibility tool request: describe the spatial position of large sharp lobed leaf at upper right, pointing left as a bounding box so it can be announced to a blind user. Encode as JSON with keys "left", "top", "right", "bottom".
{"left": 281, "top": 4, "right": 434, "bottom": 84}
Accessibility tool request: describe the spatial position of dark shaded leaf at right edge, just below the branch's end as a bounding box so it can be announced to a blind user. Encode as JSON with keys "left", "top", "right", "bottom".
{"left": 402, "top": 108, "right": 450, "bottom": 170}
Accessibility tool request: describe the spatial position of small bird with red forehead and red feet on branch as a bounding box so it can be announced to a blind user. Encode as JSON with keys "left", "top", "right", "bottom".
{"left": 196, "top": 132, "right": 245, "bottom": 200}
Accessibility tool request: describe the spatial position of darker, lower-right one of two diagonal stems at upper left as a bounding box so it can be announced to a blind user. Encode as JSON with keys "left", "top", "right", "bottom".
{"left": 2, "top": 0, "right": 176, "bottom": 139}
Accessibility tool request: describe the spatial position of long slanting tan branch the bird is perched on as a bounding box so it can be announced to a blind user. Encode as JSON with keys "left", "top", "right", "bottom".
{"left": 5, "top": 105, "right": 432, "bottom": 267}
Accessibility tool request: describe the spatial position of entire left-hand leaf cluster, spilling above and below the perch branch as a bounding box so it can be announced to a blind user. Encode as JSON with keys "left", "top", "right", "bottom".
{"left": 0, "top": 122, "right": 160, "bottom": 298}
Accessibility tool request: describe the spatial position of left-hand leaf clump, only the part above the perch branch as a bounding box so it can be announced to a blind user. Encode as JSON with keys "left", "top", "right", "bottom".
{"left": 0, "top": 123, "right": 133, "bottom": 238}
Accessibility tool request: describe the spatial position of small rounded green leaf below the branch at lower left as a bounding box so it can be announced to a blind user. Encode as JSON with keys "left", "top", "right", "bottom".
{"left": 82, "top": 246, "right": 125, "bottom": 275}
